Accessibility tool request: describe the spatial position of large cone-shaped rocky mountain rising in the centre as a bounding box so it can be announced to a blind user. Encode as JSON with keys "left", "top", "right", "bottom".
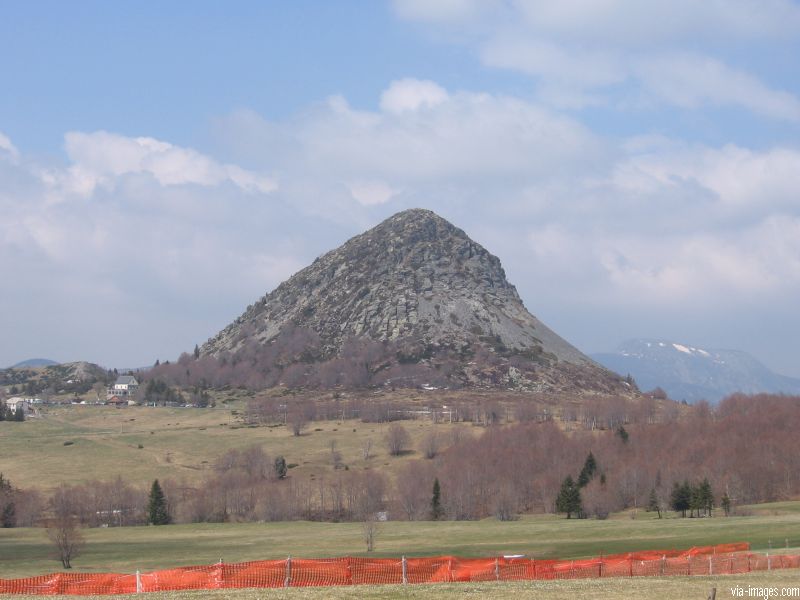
{"left": 200, "top": 209, "right": 624, "bottom": 391}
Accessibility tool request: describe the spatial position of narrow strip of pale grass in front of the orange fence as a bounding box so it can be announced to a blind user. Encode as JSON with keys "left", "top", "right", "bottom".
{"left": 1, "top": 570, "right": 800, "bottom": 600}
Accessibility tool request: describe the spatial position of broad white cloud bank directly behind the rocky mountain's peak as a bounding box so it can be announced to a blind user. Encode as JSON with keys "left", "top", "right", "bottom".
{"left": 0, "top": 80, "right": 800, "bottom": 372}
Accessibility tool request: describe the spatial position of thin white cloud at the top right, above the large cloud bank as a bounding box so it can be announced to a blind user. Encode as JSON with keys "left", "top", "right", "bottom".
{"left": 395, "top": 0, "right": 800, "bottom": 122}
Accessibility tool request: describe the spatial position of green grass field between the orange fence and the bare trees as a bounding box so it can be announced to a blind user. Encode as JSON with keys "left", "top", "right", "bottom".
{"left": 0, "top": 511, "right": 800, "bottom": 578}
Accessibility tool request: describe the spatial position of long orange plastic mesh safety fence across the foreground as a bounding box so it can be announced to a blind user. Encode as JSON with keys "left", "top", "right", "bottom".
{"left": 0, "top": 544, "right": 800, "bottom": 595}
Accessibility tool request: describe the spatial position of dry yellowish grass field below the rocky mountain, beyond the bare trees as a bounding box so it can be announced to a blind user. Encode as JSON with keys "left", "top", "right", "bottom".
{"left": 0, "top": 403, "right": 466, "bottom": 489}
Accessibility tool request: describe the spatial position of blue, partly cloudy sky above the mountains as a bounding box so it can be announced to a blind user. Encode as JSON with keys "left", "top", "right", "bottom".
{"left": 0, "top": 0, "right": 800, "bottom": 376}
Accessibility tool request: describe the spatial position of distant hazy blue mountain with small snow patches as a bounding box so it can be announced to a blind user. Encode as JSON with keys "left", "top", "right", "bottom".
{"left": 592, "top": 339, "right": 800, "bottom": 402}
